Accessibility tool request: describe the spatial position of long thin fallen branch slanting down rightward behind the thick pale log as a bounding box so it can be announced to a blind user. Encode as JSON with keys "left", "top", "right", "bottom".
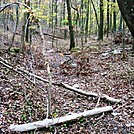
{"left": 0, "top": 57, "right": 122, "bottom": 103}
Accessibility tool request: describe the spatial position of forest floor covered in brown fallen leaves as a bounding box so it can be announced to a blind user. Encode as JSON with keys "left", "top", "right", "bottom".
{"left": 0, "top": 30, "right": 134, "bottom": 134}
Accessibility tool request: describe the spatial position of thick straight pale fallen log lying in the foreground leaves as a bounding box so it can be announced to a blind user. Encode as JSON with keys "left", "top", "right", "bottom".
{"left": 9, "top": 106, "right": 113, "bottom": 132}
